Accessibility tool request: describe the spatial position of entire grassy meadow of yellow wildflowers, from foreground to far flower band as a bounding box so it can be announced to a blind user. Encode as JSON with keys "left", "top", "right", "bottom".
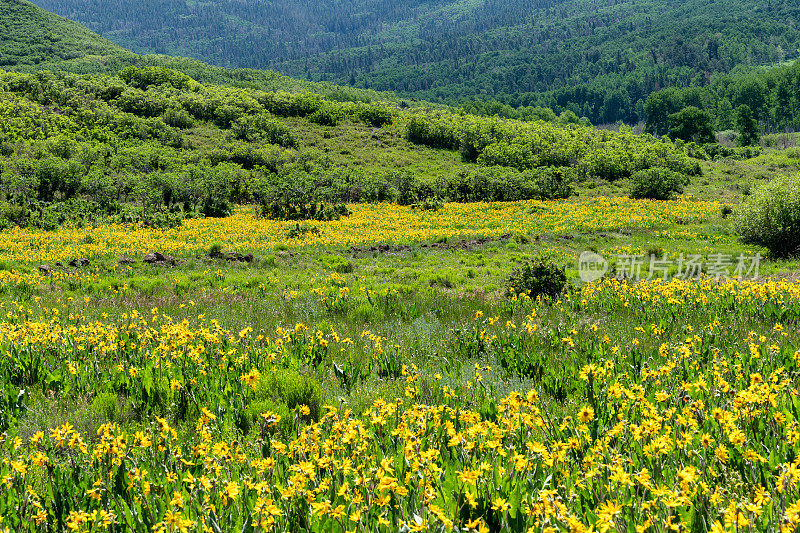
{"left": 0, "top": 198, "right": 800, "bottom": 532}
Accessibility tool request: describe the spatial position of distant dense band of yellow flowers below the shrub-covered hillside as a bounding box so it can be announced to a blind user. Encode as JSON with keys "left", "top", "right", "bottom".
{"left": 0, "top": 197, "right": 720, "bottom": 263}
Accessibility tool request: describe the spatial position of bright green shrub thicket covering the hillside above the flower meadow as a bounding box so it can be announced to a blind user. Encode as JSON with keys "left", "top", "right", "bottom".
{"left": 0, "top": 66, "right": 699, "bottom": 228}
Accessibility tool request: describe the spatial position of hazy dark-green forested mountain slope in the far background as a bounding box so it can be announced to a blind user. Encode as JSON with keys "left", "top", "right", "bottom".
{"left": 28, "top": 0, "right": 800, "bottom": 123}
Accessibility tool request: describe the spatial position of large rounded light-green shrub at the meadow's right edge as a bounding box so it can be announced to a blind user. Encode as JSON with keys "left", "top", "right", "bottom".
{"left": 734, "top": 176, "right": 800, "bottom": 257}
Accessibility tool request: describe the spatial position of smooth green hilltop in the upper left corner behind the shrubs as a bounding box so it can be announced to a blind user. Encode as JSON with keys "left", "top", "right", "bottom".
{"left": 0, "top": 0, "right": 131, "bottom": 68}
